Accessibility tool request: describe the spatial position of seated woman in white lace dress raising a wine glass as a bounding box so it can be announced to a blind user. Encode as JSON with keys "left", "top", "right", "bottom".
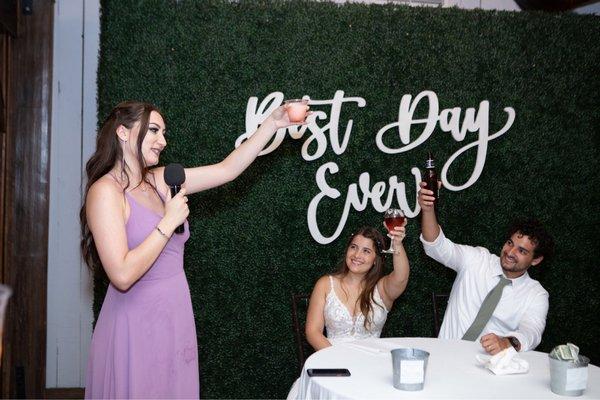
{"left": 306, "top": 222, "right": 409, "bottom": 350}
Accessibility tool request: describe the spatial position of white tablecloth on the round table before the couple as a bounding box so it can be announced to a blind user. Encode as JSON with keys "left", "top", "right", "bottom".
{"left": 298, "top": 338, "right": 600, "bottom": 400}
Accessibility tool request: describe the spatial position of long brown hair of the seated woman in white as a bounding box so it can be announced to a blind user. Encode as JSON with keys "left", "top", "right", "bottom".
{"left": 334, "top": 226, "right": 385, "bottom": 330}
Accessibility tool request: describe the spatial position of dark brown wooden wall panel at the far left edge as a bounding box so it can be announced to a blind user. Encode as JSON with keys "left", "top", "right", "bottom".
{"left": 0, "top": 0, "right": 54, "bottom": 398}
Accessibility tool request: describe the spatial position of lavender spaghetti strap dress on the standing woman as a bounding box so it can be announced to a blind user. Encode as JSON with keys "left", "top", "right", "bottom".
{"left": 85, "top": 193, "right": 200, "bottom": 399}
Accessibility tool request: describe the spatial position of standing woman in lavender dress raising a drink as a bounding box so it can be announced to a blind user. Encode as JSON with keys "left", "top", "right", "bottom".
{"left": 80, "top": 102, "right": 302, "bottom": 398}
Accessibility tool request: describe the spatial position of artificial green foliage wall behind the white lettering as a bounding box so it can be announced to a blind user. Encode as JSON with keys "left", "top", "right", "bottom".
{"left": 95, "top": 0, "right": 600, "bottom": 398}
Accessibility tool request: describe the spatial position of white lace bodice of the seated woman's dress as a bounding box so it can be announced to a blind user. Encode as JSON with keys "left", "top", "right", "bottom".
{"left": 325, "top": 275, "right": 388, "bottom": 344}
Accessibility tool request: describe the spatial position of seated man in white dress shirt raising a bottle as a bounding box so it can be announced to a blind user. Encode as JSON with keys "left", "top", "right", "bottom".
{"left": 418, "top": 183, "right": 554, "bottom": 354}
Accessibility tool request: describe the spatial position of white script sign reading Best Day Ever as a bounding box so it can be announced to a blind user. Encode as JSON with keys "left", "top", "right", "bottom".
{"left": 235, "top": 90, "right": 515, "bottom": 244}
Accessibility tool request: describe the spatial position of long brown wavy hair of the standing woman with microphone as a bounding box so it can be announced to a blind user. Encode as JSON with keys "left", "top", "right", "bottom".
{"left": 79, "top": 101, "right": 164, "bottom": 272}
